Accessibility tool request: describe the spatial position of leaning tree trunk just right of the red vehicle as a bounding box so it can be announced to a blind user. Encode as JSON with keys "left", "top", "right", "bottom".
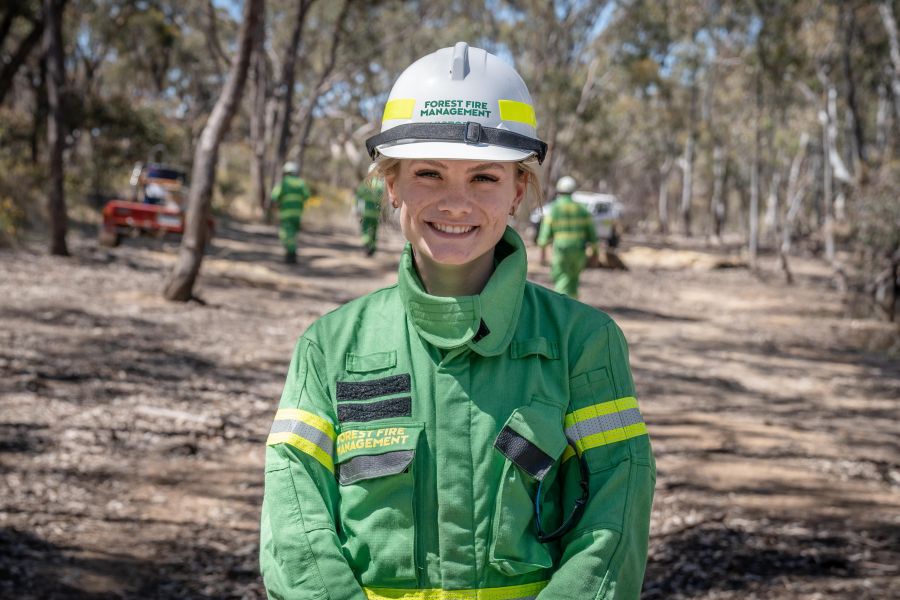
{"left": 163, "top": 0, "right": 265, "bottom": 302}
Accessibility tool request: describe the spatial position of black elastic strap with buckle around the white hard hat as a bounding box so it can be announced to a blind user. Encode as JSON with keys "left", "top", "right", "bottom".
{"left": 366, "top": 121, "right": 547, "bottom": 163}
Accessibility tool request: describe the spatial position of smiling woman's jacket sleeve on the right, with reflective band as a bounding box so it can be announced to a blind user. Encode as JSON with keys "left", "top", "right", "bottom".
{"left": 538, "top": 321, "right": 656, "bottom": 600}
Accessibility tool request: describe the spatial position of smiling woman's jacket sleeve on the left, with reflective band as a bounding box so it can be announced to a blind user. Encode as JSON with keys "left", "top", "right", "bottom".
{"left": 260, "top": 338, "right": 366, "bottom": 600}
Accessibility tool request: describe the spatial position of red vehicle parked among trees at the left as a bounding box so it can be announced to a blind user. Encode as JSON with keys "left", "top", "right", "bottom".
{"left": 100, "top": 163, "right": 204, "bottom": 246}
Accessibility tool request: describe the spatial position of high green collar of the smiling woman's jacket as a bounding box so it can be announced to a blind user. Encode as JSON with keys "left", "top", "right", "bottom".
{"left": 399, "top": 227, "right": 527, "bottom": 356}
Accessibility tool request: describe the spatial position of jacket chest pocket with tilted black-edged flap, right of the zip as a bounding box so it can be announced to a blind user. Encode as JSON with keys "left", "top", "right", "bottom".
{"left": 488, "top": 398, "right": 566, "bottom": 575}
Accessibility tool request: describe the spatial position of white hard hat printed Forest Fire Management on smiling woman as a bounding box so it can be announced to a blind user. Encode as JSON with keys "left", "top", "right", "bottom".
{"left": 366, "top": 42, "right": 547, "bottom": 162}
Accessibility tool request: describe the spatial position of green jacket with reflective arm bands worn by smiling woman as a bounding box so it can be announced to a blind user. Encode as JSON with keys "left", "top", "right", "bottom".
{"left": 260, "top": 229, "right": 656, "bottom": 600}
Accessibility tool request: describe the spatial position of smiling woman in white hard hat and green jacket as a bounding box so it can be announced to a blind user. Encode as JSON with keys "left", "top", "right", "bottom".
{"left": 261, "top": 42, "right": 656, "bottom": 600}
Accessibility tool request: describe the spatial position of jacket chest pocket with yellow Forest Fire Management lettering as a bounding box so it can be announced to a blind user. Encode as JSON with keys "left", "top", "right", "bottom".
{"left": 336, "top": 423, "right": 424, "bottom": 585}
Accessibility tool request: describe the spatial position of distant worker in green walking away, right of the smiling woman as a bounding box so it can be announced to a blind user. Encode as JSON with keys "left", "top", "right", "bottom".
{"left": 537, "top": 175, "right": 598, "bottom": 298}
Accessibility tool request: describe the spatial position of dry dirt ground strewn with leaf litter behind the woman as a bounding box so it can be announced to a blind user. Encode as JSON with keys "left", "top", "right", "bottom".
{"left": 0, "top": 217, "right": 900, "bottom": 600}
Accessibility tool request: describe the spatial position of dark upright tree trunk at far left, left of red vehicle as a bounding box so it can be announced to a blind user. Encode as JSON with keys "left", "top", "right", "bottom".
{"left": 44, "top": 0, "right": 69, "bottom": 256}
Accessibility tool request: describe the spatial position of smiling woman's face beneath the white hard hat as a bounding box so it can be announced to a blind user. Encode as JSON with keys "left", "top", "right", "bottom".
{"left": 385, "top": 159, "right": 527, "bottom": 266}
